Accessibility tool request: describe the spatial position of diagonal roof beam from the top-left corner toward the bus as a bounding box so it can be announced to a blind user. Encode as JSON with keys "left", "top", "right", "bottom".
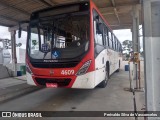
{"left": 0, "top": 0, "right": 30, "bottom": 16}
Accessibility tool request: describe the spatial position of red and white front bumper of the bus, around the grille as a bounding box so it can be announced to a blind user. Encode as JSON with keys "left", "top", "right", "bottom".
{"left": 26, "top": 71, "right": 95, "bottom": 89}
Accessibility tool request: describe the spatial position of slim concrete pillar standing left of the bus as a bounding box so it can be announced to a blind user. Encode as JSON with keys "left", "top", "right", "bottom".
{"left": 10, "top": 30, "right": 17, "bottom": 76}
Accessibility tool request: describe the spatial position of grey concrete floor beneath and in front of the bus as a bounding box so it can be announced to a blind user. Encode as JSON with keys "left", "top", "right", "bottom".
{"left": 0, "top": 66, "right": 144, "bottom": 120}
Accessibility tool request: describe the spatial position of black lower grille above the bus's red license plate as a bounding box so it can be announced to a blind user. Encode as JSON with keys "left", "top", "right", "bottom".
{"left": 35, "top": 78, "right": 71, "bottom": 87}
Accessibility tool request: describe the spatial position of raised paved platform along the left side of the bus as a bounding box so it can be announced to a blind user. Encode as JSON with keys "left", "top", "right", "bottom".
{"left": 0, "top": 76, "right": 41, "bottom": 103}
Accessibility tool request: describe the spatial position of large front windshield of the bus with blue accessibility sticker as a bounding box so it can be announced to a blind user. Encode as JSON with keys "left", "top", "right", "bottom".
{"left": 28, "top": 12, "right": 89, "bottom": 59}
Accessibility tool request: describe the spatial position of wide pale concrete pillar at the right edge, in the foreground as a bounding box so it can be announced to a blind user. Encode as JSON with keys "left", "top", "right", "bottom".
{"left": 143, "top": 0, "right": 160, "bottom": 120}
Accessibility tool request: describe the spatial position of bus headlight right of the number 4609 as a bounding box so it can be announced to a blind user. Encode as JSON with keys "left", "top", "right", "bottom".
{"left": 76, "top": 60, "right": 91, "bottom": 76}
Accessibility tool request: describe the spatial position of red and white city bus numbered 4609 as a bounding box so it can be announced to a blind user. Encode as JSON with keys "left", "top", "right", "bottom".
{"left": 26, "top": 0, "right": 122, "bottom": 89}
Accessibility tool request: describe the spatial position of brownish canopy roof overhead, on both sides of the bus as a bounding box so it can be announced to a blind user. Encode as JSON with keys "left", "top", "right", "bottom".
{"left": 0, "top": 0, "right": 141, "bottom": 29}
